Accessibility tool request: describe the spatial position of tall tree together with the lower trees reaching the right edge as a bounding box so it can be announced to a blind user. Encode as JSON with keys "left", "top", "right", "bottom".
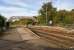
{"left": 37, "top": 2, "right": 74, "bottom": 26}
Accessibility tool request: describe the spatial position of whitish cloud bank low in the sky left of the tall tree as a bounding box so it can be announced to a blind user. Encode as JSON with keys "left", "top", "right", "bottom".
{"left": 0, "top": 7, "right": 37, "bottom": 18}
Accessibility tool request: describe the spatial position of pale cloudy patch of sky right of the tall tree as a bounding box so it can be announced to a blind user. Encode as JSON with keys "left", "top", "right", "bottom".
{"left": 53, "top": 0, "right": 74, "bottom": 10}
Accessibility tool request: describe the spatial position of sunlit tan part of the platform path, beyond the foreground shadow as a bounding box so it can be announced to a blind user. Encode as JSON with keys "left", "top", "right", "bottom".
{"left": 1, "top": 27, "right": 39, "bottom": 41}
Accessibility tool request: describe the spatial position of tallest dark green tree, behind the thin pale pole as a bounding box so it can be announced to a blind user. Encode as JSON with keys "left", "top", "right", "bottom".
{"left": 38, "top": 2, "right": 56, "bottom": 25}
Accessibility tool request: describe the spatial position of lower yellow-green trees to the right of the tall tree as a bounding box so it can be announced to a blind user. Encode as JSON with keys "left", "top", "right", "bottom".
{"left": 56, "top": 10, "right": 74, "bottom": 26}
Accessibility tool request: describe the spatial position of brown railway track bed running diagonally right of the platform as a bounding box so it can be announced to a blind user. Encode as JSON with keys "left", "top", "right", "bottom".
{"left": 30, "top": 28, "right": 74, "bottom": 48}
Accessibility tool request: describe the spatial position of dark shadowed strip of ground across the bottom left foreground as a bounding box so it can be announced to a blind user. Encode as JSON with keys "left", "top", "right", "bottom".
{"left": 0, "top": 40, "right": 50, "bottom": 50}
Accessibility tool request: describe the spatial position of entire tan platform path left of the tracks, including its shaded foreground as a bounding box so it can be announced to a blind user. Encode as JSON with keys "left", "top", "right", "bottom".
{"left": 0, "top": 27, "right": 53, "bottom": 50}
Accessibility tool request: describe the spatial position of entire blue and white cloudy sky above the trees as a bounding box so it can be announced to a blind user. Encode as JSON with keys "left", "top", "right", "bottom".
{"left": 0, "top": 0, "right": 74, "bottom": 18}
